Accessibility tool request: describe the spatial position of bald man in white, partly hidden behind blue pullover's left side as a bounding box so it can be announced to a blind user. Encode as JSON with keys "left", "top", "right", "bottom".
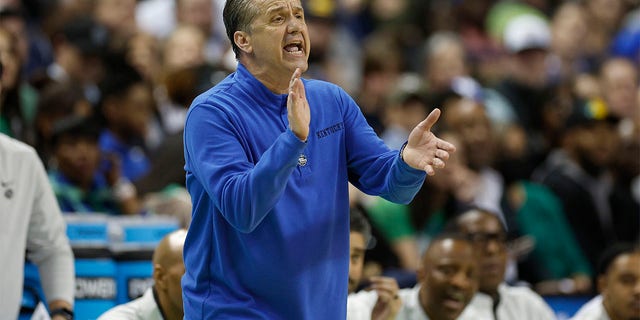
{"left": 98, "top": 229, "right": 187, "bottom": 320}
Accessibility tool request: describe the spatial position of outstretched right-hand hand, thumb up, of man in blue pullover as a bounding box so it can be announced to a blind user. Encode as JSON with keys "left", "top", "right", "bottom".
{"left": 402, "top": 108, "right": 456, "bottom": 176}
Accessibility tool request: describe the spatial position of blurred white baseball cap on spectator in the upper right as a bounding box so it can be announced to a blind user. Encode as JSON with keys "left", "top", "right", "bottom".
{"left": 503, "top": 13, "right": 551, "bottom": 53}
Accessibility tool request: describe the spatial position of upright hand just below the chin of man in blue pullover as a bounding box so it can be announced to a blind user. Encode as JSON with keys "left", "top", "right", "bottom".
{"left": 287, "top": 68, "right": 311, "bottom": 141}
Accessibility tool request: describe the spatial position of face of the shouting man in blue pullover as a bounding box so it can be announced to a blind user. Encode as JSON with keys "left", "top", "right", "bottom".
{"left": 241, "top": 0, "right": 311, "bottom": 79}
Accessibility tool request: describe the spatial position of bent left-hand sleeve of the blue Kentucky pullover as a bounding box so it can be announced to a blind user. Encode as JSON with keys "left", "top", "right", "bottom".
{"left": 184, "top": 106, "right": 306, "bottom": 233}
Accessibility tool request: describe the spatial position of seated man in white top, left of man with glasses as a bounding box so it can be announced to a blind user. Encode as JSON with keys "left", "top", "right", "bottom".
{"left": 396, "top": 234, "right": 482, "bottom": 320}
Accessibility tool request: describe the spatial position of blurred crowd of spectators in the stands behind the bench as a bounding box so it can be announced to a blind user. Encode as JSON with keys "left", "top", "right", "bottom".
{"left": 0, "top": 0, "right": 640, "bottom": 302}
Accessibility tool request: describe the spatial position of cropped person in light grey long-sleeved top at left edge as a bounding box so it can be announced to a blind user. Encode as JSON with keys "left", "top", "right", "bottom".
{"left": 0, "top": 59, "right": 75, "bottom": 320}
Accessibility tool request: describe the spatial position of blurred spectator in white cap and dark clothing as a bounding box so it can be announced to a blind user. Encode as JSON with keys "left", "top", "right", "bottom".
{"left": 485, "top": 13, "right": 551, "bottom": 183}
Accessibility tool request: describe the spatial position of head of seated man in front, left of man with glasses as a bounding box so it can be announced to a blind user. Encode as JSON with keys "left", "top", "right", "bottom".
{"left": 419, "top": 239, "right": 478, "bottom": 320}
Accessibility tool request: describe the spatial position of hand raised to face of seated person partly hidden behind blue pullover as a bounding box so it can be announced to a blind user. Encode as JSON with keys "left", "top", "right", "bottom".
{"left": 370, "top": 277, "right": 402, "bottom": 320}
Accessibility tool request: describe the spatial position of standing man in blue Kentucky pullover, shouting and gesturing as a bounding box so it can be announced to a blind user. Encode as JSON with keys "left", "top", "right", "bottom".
{"left": 182, "top": 0, "right": 455, "bottom": 319}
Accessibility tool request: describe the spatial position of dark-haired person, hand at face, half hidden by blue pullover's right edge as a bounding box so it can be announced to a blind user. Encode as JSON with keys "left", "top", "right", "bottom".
{"left": 347, "top": 208, "right": 402, "bottom": 320}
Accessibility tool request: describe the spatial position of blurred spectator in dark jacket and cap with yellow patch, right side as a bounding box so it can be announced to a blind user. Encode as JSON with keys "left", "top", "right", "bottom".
{"left": 533, "top": 101, "right": 624, "bottom": 270}
